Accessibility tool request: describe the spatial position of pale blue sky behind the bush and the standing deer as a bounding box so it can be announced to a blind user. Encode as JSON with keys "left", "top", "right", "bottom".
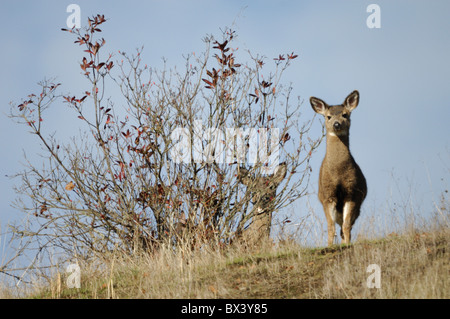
{"left": 0, "top": 0, "right": 450, "bottom": 250}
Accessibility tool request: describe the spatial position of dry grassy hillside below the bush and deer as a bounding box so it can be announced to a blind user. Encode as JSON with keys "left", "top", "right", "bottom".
{"left": 24, "top": 228, "right": 450, "bottom": 298}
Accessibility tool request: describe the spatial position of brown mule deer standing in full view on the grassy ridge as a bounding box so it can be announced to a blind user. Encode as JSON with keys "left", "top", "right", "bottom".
{"left": 310, "top": 91, "right": 367, "bottom": 246}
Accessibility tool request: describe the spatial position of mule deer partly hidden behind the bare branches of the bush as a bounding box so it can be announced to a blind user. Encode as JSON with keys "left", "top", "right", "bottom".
{"left": 238, "top": 162, "right": 287, "bottom": 241}
